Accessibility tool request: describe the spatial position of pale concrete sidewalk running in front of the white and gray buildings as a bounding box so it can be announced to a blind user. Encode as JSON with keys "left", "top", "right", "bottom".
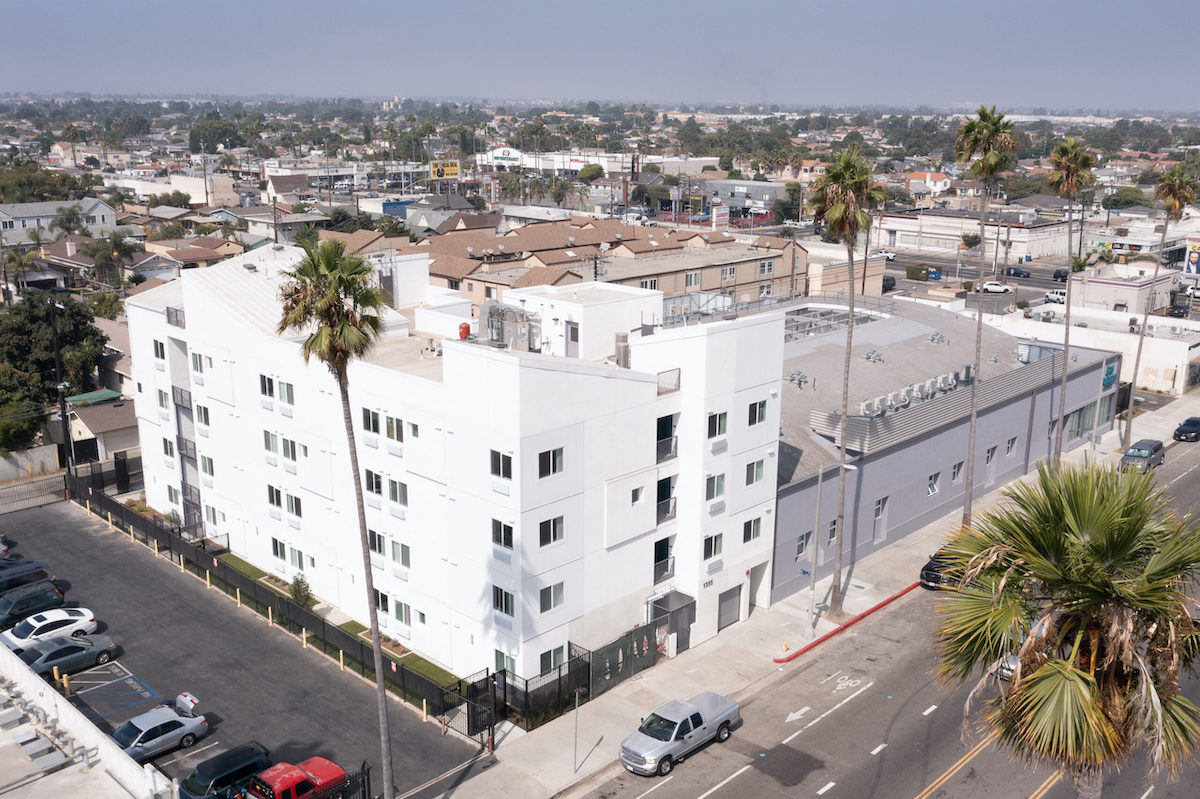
{"left": 446, "top": 392, "right": 1200, "bottom": 799}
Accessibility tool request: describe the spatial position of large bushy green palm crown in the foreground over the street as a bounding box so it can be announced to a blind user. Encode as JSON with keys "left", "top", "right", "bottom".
{"left": 935, "top": 462, "right": 1200, "bottom": 797}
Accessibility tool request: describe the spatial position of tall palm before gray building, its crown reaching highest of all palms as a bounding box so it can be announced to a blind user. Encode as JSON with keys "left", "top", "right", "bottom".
{"left": 954, "top": 106, "right": 1016, "bottom": 527}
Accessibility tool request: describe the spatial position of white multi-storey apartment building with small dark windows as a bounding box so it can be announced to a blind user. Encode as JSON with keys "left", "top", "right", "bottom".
{"left": 127, "top": 246, "right": 784, "bottom": 677}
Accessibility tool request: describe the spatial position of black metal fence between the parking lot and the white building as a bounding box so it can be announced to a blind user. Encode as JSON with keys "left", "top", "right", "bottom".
{"left": 56, "top": 475, "right": 492, "bottom": 745}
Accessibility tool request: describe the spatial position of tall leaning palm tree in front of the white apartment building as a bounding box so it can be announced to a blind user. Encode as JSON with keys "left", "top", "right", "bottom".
{"left": 277, "top": 241, "right": 396, "bottom": 797}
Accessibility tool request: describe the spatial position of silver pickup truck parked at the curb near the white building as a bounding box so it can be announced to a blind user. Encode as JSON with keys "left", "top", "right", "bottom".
{"left": 620, "top": 691, "right": 742, "bottom": 776}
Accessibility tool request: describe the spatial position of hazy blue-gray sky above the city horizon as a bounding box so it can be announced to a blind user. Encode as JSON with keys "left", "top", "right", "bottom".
{"left": 0, "top": 0, "right": 1200, "bottom": 112}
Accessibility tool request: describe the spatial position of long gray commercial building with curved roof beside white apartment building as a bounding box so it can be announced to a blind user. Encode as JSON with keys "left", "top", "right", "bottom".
{"left": 772, "top": 299, "right": 1121, "bottom": 602}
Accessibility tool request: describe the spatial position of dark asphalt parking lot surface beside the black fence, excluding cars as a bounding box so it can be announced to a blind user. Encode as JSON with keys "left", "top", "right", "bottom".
{"left": 0, "top": 503, "right": 479, "bottom": 793}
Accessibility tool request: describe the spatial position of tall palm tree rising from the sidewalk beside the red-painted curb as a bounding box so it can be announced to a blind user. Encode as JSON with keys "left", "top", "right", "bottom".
{"left": 809, "top": 148, "right": 887, "bottom": 618}
